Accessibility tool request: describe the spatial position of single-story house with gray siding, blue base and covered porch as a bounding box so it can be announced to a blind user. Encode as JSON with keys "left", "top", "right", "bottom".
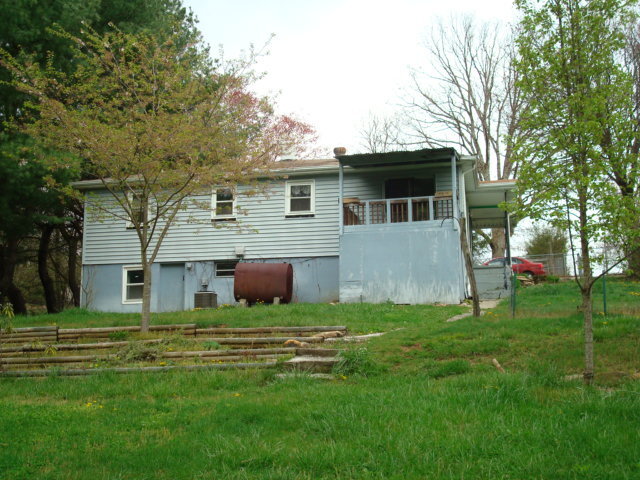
{"left": 77, "top": 148, "right": 514, "bottom": 312}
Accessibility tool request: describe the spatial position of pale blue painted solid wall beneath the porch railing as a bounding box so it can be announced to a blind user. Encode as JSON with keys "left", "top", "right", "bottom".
{"left": 340, "top": 220, "right": 465, "bottom": 304}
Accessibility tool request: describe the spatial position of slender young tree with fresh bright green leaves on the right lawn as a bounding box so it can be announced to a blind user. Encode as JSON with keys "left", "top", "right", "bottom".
{"left": 515, "top": 0, "right": 640, "bottom": 383}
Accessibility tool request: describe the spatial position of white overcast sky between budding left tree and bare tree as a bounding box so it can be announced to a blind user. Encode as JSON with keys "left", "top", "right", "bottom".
{"left": 184, "top": 0, "right": 515, "bottom": 154}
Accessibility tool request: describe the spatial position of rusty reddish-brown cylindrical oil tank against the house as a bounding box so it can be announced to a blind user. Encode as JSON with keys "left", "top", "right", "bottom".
{"left": 233, "top": 263, "right": 293, "bottom": 303}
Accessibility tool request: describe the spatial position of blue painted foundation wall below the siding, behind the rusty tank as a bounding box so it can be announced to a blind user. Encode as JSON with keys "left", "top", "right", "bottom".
{"left": 82, "top": 257, "right": 338, "bottom": 313}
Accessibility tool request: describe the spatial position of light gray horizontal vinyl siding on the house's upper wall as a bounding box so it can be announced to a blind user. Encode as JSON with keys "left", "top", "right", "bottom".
{"left": 83, "top": 167, "right": 458, "bottom": 265}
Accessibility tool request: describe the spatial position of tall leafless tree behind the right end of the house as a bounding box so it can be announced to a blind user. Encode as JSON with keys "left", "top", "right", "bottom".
{"left": 403, "top": 17, "right": 526, "bottom": 257}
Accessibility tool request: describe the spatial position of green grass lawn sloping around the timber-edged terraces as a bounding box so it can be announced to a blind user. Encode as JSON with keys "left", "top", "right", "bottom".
{"left": 0, "top": 281, "right": 640, "bottom": 480}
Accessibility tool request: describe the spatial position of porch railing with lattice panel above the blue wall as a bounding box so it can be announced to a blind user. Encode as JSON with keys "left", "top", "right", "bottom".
{"left": 343, "top": 197, "right": 453, "bottom": 226}
